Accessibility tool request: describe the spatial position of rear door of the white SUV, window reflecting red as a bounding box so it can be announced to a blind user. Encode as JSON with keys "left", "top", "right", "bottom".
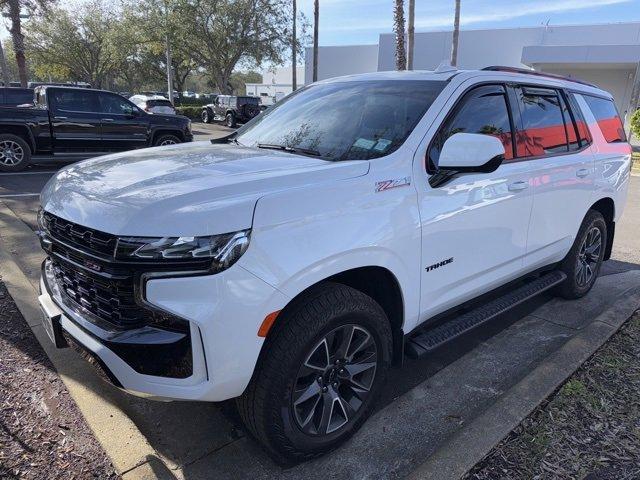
{"left": 516, "top": 85, "right": 595, "bottom": 269}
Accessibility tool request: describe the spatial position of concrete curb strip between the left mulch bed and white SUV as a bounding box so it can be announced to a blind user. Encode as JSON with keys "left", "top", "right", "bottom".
{"left": 0, "top": 202, "right": 165, "bottom": 478}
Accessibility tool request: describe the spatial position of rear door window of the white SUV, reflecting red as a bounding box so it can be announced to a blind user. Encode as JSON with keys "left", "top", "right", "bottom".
{"left": 517, "top": 87, "right": 567, "bottom": 157}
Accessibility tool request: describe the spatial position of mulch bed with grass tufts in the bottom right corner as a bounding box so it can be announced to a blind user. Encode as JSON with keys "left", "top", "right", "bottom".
{"left": 465, "top": 313, "right": 640, "bottom": 480}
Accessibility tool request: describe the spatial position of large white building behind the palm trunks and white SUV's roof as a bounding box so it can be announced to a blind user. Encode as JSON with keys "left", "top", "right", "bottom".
{"left": 305, "top": 22, "right": 640, "bottom": 124}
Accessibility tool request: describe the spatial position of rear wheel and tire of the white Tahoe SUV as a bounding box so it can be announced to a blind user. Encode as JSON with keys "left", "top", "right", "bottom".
{"left": 556, "top": 210, "right": 608, "bottom": 299}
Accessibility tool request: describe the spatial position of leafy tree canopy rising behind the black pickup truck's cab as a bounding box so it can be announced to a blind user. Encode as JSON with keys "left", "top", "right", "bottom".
{"left": 28, "top": 2, "right": 136, "bottom": 88}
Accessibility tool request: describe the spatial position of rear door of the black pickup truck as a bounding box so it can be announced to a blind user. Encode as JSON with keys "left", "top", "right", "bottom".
{"left": 47, "top": 88, "right": 103, "bottom": 152}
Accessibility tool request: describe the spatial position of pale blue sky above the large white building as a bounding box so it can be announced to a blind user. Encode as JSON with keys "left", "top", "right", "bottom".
{"left": 298, "top": 0, "right": 640, "bottom": 45}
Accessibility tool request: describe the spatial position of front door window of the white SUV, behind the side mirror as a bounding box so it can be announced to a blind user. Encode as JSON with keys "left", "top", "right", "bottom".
{"left": 429, "top": 85, "right": 513, "bottom": 167}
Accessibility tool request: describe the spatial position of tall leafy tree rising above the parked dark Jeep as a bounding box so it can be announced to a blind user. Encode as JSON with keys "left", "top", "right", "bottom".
{"left": 177, "top": 0, "right": 292, "bottom": 93}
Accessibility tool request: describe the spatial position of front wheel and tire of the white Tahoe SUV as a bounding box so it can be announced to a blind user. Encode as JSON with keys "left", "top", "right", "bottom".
{"left": 236, "top": 282, "right": 392, "bottom": 462}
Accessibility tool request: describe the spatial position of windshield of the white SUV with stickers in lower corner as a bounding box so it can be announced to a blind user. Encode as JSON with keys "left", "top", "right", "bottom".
{"left": 235, "top": 80, "right": 446, "bottom": 161}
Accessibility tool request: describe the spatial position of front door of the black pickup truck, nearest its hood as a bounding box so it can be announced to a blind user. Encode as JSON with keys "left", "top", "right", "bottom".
{"left": 98, "top": 92, "right": 149, "bottom": 151}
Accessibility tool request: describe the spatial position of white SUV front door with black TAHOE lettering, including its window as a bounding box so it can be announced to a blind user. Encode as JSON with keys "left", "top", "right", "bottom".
{"left": 418, "top": 85, "right": 533, "bottom": 321}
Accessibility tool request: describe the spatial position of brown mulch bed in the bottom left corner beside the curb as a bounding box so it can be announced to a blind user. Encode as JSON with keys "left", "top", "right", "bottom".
{"left": 0, "top": 282, "right": 118, "bottom": 480}
